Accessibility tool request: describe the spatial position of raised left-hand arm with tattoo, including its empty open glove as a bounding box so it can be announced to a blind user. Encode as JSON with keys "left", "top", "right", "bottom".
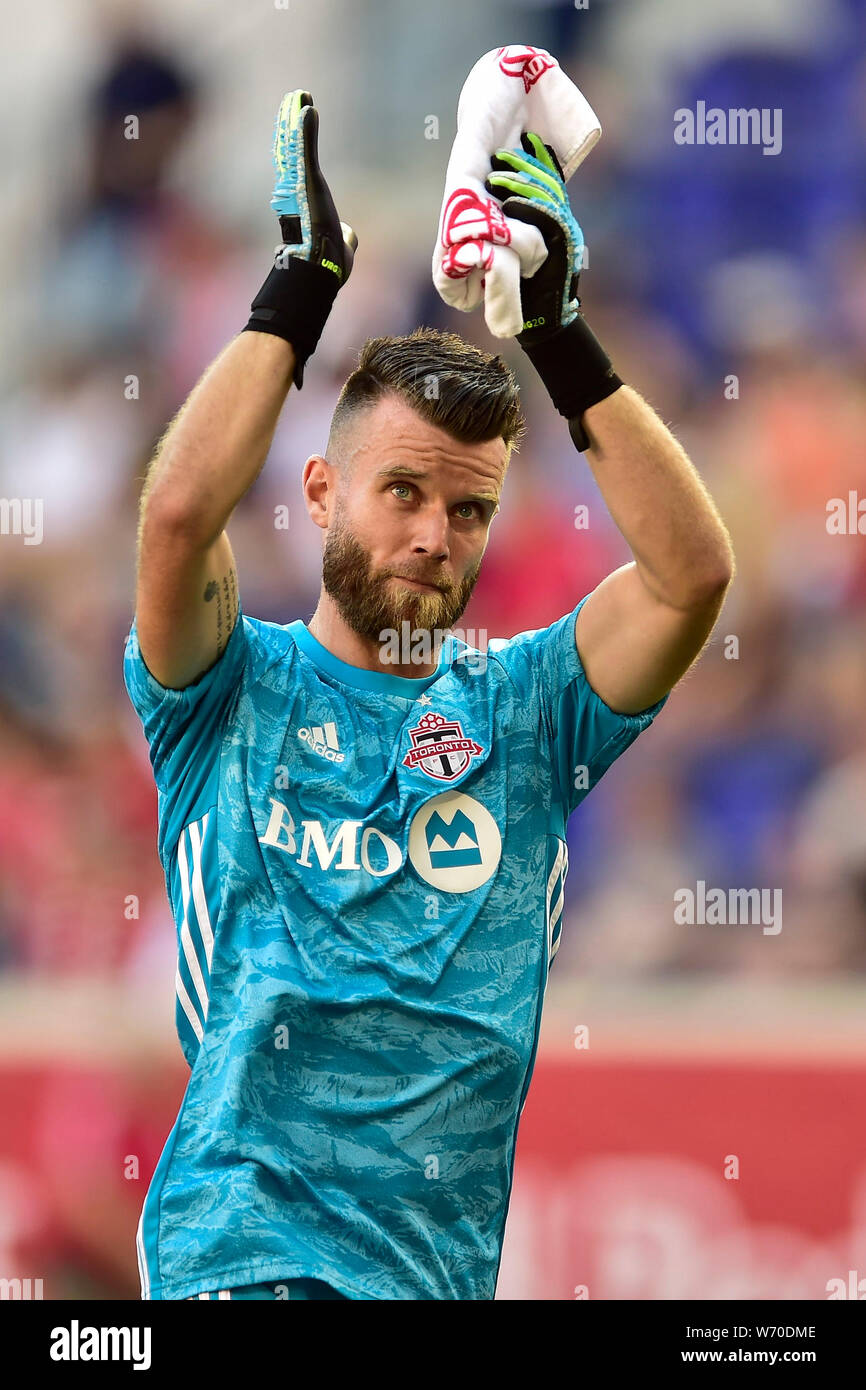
{"left": 135, "top": 90, "right": 357, "bottom": 689}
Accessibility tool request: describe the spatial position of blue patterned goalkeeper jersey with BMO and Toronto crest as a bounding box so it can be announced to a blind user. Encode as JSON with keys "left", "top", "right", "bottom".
{"left": 124, "top": 600, "right": 664, "bottom": 1300}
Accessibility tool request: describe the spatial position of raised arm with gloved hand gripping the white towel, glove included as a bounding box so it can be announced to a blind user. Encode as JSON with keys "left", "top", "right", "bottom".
{"left": 487, "top": 132, "right": 734, "bottom": 714}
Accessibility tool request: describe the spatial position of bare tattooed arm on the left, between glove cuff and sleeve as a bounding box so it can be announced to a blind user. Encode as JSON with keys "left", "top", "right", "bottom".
{"left": 135, "top": 332, "right": 295, "bottom": 689}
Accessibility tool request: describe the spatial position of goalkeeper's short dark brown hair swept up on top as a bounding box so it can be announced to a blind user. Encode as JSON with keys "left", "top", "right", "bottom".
{"left": 328, "top": 328, "right": 525, "bottom": 455}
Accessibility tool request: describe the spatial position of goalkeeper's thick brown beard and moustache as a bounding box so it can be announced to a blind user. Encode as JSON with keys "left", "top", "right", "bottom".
{"left": 322, "top": 520, "right": 481, "bottom": 642}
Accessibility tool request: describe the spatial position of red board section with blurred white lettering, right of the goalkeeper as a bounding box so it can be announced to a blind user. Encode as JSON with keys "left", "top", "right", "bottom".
{"left": 498, "top": 1052, "right": 866, "bottom": 1300}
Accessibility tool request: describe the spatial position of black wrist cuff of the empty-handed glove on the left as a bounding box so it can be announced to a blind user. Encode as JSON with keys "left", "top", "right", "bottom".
{"left": 242, "top": 254, "right": 339, "bottom": 391}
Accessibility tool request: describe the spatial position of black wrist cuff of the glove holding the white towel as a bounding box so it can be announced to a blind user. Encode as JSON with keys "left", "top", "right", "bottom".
{"left": 517, "top": 314, "right": 623, "bottom": 452}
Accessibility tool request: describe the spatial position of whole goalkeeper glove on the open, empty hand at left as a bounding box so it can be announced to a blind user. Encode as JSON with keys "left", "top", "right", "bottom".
{"left": 245, "top": 90, "right": 357, "bottom": 391}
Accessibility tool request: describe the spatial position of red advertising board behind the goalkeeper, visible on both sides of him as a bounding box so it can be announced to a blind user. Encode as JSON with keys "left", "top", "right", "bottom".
{"left": 0, "top": 1052, "right": 866, "bottom": 1300}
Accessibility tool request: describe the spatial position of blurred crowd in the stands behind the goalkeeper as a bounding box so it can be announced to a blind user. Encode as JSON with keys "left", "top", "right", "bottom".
{"left": 0, "top": 3, "right": 866, "bottom": 987}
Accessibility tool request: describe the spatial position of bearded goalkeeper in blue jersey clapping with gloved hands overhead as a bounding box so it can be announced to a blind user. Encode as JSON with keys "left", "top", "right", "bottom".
{"left": 124, "top": 92, "right": 733, "bottom": 1300}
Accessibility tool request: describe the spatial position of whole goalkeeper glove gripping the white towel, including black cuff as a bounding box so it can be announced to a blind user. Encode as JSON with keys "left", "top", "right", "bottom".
{"left": 485, "top": 131, "right": 623, "bottom": 452}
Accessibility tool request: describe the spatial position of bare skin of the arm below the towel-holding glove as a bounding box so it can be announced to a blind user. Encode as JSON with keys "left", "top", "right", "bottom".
{"left": 575, "top": 385, "right": 734, "bottom": 714}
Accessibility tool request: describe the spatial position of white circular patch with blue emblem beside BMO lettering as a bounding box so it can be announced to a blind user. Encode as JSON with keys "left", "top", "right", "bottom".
{"left": 409, "top": 791, "right": 502, "bottom": 892}
